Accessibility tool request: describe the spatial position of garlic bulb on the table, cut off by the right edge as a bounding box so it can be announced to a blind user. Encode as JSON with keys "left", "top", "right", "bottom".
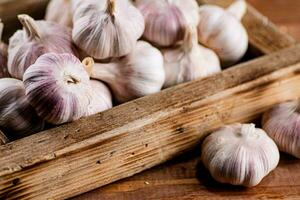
{"left": 262, "top": 100, "right": 300, "bottom": 158}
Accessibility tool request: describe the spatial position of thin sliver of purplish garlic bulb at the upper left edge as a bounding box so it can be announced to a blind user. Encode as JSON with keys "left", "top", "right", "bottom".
{"left": 0, "top": 19, "right": 9, "bottom": 78}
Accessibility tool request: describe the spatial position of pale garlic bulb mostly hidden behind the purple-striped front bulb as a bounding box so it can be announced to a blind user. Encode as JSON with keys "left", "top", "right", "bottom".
{"left": 86, "top": 80, "right": 113, "bottom": 116}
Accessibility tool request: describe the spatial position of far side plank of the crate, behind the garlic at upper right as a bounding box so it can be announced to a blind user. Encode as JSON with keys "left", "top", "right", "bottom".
{"left": 198, "top": 0, "right": 296, "bottom": 54}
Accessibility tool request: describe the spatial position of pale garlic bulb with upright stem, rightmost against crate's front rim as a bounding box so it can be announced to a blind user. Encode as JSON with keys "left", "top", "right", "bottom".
{"left": 163, "top": 28, "right": 221, "bottom": 87}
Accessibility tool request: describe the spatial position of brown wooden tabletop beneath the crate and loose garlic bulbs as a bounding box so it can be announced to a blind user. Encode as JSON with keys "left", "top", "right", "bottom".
{"left": 73, "top": 0, "right": 300, "bottom": 200}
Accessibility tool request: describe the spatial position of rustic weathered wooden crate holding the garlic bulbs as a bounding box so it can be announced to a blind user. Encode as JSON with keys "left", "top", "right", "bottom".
{"left": 0, "top": 0, "right": 300, "bottom": 199}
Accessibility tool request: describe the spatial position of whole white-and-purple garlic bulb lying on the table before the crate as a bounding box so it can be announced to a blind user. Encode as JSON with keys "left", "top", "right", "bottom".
{"left": 201, "top": 124, "right": 279, "bottom": 187}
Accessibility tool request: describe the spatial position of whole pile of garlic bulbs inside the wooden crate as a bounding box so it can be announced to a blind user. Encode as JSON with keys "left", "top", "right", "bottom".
{"left": 0, "top": 0, "right": 248, "bottom": 139}
